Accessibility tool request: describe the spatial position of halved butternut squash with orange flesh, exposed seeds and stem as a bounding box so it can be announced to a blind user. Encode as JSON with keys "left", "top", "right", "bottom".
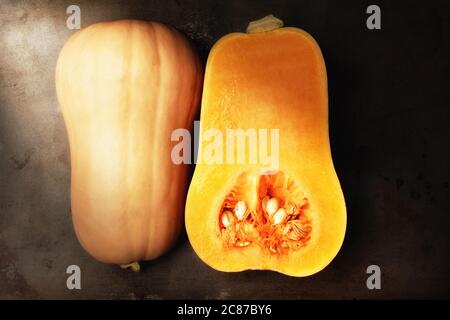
{"left": 186, "top": 16, "right": 346, "bottom": 276}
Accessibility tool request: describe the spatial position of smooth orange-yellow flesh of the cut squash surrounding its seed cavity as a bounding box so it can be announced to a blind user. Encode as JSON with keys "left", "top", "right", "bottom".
{"left": 186, "top": 28, "right": 346, "bottom": 276}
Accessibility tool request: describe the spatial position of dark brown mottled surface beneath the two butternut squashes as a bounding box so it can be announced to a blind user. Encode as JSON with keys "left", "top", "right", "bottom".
{"left": 0, "top": 0, "right": 450, "bottom": 299}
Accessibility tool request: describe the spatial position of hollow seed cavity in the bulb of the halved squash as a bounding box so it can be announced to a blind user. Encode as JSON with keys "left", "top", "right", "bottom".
{"left": 219, "top": 171, "right": 312, "bottom": 255}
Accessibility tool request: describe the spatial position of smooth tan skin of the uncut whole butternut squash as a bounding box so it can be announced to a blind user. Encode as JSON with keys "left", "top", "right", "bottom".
{"left": 56, "top": 20, "right": 202, "bottom": 264}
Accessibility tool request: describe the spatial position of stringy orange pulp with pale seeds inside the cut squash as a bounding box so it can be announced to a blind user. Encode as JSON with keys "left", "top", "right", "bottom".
{"left": 219, "top": 172, "right": 312, "bottom": 254}
